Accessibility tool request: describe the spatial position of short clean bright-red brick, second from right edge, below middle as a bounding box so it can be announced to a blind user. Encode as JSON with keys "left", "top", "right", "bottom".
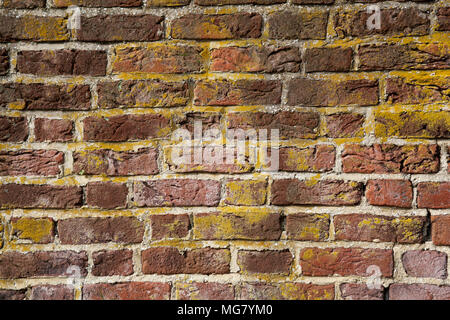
{"left": 366, "top": 180, "right": 413, "bottom": 208}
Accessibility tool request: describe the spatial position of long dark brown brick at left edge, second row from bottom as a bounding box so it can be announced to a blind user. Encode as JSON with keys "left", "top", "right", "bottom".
{"left": 0, "top": 251, "right": 88, "bottom": 279}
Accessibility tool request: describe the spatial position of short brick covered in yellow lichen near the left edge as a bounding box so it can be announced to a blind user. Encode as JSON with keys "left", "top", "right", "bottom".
{"left": 10, "top": 217, "right": 55, "bottom": 243}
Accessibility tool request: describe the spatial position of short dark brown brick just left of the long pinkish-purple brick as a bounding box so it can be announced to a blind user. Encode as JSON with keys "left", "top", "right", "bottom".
{"left": 86, "top": 182, "right": 128, "bottom": 209}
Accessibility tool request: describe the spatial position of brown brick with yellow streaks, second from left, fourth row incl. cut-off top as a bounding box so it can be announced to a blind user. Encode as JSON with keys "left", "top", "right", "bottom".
{"left": 97, "top": 80, "right": 190, "bottom": 109}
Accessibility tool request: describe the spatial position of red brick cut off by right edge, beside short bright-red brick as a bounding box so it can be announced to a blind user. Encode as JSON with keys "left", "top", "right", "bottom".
{"left": 417, "top": 182, "right": 450, "bottom": 209}
